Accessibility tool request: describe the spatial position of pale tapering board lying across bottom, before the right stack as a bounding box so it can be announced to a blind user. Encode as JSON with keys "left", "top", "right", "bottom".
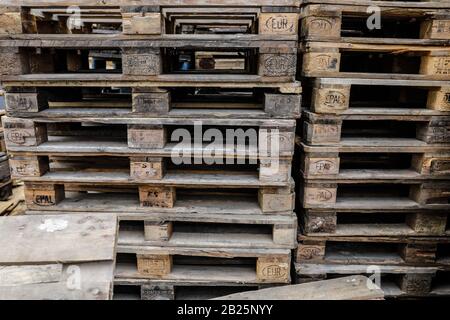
{"left": 213, "top": 276, "right": 384, "bottom": 300}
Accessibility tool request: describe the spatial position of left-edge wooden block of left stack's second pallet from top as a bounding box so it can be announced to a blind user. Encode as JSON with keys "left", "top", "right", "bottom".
{"left": 0, "top": 47, "right": 30, "bottom": 75}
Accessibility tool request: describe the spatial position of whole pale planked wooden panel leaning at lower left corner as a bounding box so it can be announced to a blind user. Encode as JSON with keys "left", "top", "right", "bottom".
{"left": 0, "top": 214, "right": 117, "bottom": 300}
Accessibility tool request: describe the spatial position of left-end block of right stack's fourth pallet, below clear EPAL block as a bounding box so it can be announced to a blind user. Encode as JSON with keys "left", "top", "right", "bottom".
{"left": 303, "top": 121, "right": 342, "bottom": 145}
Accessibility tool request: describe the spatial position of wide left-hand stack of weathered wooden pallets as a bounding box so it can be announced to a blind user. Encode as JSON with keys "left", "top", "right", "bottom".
{"left": 0, "top": 0, "right": 301, "bottom": 299}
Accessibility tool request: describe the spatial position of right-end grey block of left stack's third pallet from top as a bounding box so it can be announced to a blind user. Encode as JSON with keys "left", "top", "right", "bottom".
{"left": 264, "top": 93, "right": 302, "bottom": 118}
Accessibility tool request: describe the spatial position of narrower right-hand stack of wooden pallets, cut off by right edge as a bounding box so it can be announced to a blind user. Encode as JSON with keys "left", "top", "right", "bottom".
{"left": 295, "top": 0, "right": 450, "bottom": 297}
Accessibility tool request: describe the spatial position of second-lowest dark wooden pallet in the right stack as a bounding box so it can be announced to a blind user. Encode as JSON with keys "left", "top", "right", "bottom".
{"left": 296, "top": 234, "right": 450, "bottom": 269}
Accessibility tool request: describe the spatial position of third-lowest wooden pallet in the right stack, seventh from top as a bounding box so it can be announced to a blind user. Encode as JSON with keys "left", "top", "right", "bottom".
{"left": 298, "top": 209, "right": 450, "bottom": 237}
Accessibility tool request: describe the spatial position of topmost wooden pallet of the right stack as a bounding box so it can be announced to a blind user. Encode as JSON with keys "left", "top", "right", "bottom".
{"left": 300, "top": 1, "right": 450, "bottom": 45}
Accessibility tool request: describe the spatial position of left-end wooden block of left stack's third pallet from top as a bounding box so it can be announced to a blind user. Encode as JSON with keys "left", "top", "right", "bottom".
{"left": 5, "top": 92, "right": 48, "bottom": 112}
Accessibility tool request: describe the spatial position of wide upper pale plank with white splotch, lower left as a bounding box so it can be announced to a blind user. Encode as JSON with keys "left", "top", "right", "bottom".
{"left": 0, "top": 214, "right": 117, "bottom": 265}
